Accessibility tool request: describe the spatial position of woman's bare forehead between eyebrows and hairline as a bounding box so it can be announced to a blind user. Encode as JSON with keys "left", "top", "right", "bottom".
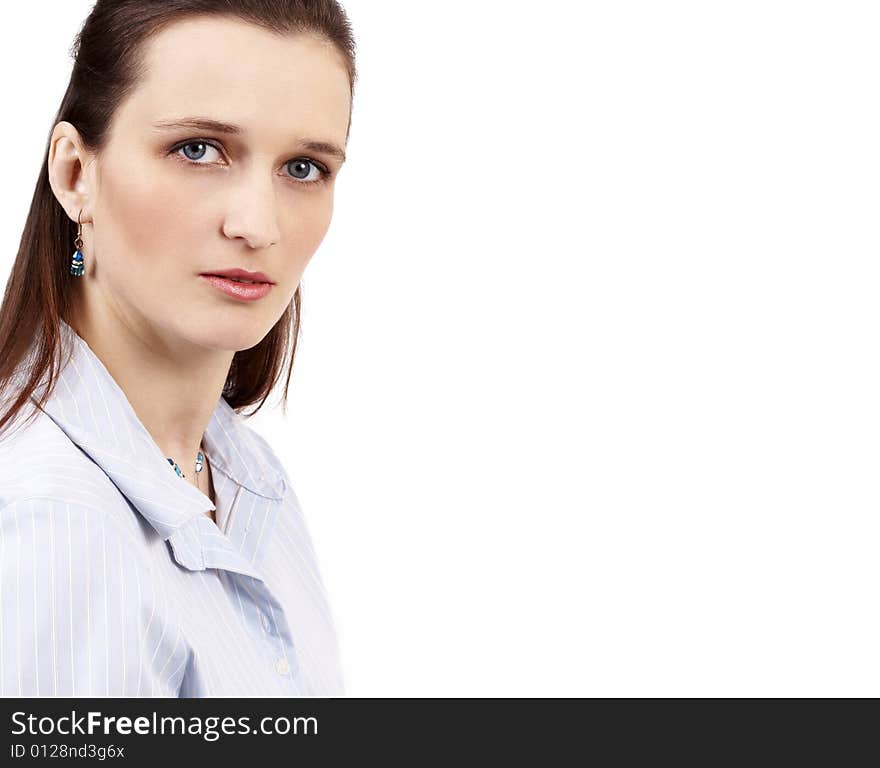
{"left": 120, "top": 17, "right": 351, "bottom": 146}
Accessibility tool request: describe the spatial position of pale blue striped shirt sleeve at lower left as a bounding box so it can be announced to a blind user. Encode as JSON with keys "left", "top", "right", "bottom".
{"left": 0, "top": 498, "right": 190, "bottom": 697}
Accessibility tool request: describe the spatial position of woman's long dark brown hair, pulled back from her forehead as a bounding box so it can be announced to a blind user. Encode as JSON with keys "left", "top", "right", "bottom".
{"left": 0, "top": 0, "right": 357, "bottom": 432}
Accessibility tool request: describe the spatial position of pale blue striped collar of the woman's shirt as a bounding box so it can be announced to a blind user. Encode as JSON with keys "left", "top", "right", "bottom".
{"left": 31, "top": 319, "right": 285, "bottom": 552}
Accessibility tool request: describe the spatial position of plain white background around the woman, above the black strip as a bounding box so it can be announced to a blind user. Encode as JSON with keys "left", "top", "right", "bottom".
{"left": 0, "top": 0, "right": 880, "bottom": 696}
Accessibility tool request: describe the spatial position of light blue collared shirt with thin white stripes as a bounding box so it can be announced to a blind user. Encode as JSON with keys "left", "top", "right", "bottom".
{"left": 0, "top": 320, "right": 344, "bottom": 697}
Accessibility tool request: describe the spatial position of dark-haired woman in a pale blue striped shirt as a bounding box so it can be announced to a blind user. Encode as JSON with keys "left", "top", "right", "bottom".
{"left": 0, "top": 0, "right": 356, "bottom": 697}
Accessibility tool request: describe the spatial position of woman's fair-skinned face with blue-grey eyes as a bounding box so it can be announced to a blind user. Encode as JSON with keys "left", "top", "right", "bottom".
{"left": 64, "top": 18, "right": 351, "bottom": 351}
